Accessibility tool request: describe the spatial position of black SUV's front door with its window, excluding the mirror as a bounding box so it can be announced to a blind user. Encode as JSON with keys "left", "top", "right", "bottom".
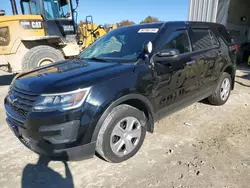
{"left": 153, "top": 29, "right": 196, "bottom": 110}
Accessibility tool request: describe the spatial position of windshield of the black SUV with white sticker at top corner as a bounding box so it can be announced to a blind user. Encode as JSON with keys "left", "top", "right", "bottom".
{"left": 80, "top": 26, "right": 159, "bottom": 62}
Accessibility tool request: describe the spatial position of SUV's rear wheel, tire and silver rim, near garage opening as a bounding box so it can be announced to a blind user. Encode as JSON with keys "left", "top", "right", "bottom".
{"left": 208, "top": 72, "right": 232, "bottom": 106}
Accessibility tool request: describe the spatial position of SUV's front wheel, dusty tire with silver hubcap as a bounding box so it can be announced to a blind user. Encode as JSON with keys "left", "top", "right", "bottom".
{"left": 96, "top": 104, "right": 147, "bottom": 163}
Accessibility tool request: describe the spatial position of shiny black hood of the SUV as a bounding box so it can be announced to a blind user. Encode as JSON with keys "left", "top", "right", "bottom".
{"left": 13, "top": 59, "right": 134, "bottom": 94}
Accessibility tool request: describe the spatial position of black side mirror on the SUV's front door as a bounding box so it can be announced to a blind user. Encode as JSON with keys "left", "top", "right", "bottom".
{"left": 154, "top": 49, "right": 180, "bottom": 61}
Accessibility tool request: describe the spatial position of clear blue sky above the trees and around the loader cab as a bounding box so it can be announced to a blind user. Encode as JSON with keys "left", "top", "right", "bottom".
{"left": 0, "top": 0, "right": 189, "bottom": 24}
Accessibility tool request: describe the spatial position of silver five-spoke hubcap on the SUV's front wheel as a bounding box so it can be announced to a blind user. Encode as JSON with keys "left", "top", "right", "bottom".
{"left": 110, "top": 117, "right": 141, "bottom": 156}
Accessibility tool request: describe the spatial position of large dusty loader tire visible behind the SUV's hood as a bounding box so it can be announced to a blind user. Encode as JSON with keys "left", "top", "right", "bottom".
{"left": 22, "top": 45, "right": 64, "bottom": 70}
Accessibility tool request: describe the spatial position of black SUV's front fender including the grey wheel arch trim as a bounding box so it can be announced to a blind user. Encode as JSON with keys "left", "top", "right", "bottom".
{"left": 81, "top": 72, "right": 154, "bottom": 144}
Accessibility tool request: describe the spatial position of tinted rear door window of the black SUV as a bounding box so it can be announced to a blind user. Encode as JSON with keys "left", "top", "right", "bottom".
{"left": 192, "top": 29, "right": 219, "bottom": 51}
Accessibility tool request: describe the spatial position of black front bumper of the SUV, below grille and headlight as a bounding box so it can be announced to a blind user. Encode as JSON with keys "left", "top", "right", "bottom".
{"left": 4, "top": 99, "right": 96, "bottom": 160}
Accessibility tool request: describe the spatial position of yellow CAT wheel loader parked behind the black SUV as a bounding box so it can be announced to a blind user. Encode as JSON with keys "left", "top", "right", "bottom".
{"left": 0, "top": 0, "right": 116, "bottom": 72}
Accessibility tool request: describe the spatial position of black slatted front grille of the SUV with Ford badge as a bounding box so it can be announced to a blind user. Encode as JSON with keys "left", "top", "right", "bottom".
{"left": 8, "top": 87, "right": 38, "bottom": 118}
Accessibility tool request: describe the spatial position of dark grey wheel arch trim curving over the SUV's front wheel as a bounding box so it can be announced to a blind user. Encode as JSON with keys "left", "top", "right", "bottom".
{"left": 91, "top": 94, "right": 154, "bottom": 142}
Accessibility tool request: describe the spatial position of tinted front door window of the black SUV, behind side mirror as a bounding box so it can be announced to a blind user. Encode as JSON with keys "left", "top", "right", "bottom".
{"left": 163, "top": 30, "right": 191, "bottom": 54}
